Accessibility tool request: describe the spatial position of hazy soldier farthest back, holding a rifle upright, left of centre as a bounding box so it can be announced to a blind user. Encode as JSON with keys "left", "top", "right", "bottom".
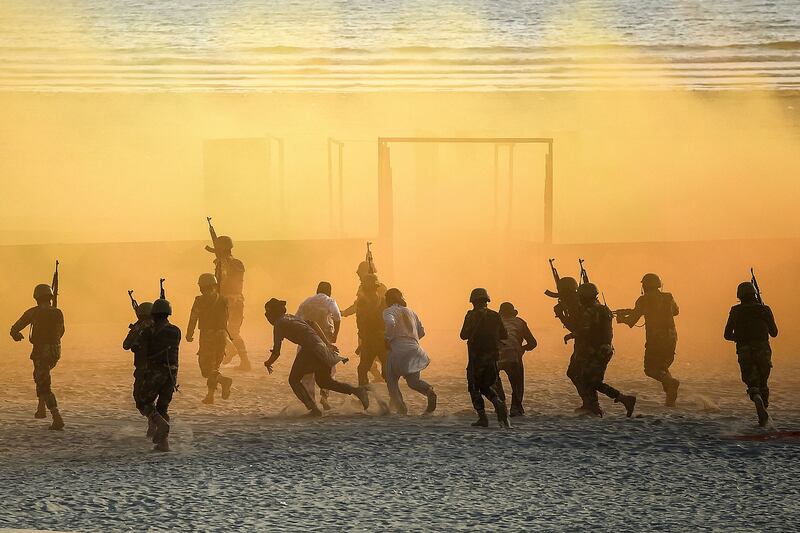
{"left": 206, "top": 235, "right": 250, "bottom": 370}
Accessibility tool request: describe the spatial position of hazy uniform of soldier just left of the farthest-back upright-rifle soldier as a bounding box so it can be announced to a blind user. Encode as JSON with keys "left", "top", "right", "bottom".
{"left": 188, "top": 292, "right": 228, "bottom": 390}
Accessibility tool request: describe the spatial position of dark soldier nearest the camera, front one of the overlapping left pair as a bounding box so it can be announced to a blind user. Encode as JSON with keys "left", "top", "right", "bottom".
{"left": 134, "top": 298, "right": 181, "bottom": 452}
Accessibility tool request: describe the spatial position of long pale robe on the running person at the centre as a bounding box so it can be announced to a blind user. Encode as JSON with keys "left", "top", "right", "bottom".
{"left": 383, "top": 304, "right": 431, "bottom": 379}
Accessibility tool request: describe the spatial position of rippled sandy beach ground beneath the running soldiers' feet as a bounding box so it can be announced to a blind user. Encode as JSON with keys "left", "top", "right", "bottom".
{"left": 0, "top": 328, "right": 800, "bottom": 531}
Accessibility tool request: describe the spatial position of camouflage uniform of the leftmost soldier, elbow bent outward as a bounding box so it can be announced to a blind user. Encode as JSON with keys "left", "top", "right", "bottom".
{"left": 11, "top": 304, "right": 64, "bottom": 412}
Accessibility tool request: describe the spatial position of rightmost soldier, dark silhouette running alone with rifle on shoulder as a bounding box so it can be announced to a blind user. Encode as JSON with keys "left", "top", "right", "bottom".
{"left": 725, "top": 281, "right": 778, "bottom": 427}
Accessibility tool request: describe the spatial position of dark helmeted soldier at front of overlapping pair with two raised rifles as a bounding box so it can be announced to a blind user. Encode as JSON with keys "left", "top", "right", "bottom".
{"left": 575, "top": 283, "right": 636, "bottom": 417}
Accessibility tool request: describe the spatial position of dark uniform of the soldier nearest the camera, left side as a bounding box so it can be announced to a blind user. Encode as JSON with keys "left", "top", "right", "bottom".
{"left": 136, "top": 321, "right": 181, "bottom": 421}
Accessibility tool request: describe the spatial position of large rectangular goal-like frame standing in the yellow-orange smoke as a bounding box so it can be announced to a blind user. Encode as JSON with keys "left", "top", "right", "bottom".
{"left": 376, "top": 137, "right": 553, "bottom": 268}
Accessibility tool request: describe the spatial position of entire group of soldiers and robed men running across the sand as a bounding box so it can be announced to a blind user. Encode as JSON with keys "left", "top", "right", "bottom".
{"left": 11, "top": 231, "right": 778, "bottom": 451}
